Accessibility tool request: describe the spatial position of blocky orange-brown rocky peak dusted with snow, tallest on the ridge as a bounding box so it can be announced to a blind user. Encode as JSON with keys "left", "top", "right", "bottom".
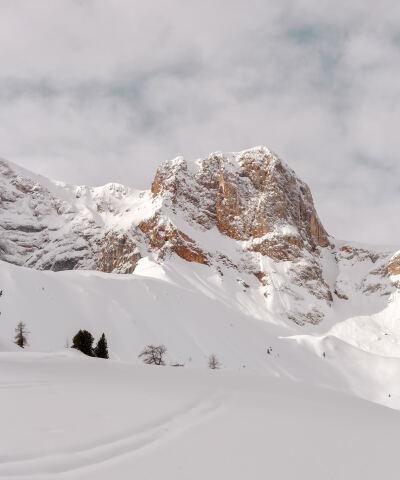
{"left": 151, "top": 147, "right": 330, "bottom": 257}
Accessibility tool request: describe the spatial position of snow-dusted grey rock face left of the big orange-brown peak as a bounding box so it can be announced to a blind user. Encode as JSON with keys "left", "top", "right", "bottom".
{"left": 0, "top": 161, "right": 143, "bottom": 273}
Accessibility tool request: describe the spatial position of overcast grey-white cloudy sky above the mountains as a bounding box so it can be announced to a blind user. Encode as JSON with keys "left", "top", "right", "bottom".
{"left": 0, "top": 0, "right": 400, "bottom": 244}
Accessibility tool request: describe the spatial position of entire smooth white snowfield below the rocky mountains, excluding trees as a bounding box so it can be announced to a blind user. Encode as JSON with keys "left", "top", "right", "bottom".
{"left": 0, "top": 255, "right": 400, "bottom": 480}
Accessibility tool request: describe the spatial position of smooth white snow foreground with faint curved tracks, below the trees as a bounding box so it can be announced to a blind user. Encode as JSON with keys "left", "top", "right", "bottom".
{"left": 0, "top": 351, "right": 400, "bottom": 480}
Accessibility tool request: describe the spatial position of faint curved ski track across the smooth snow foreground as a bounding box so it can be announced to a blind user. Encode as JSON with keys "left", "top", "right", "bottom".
{"left": 0, "top": 394, "right": 224, "bottom": 478}
